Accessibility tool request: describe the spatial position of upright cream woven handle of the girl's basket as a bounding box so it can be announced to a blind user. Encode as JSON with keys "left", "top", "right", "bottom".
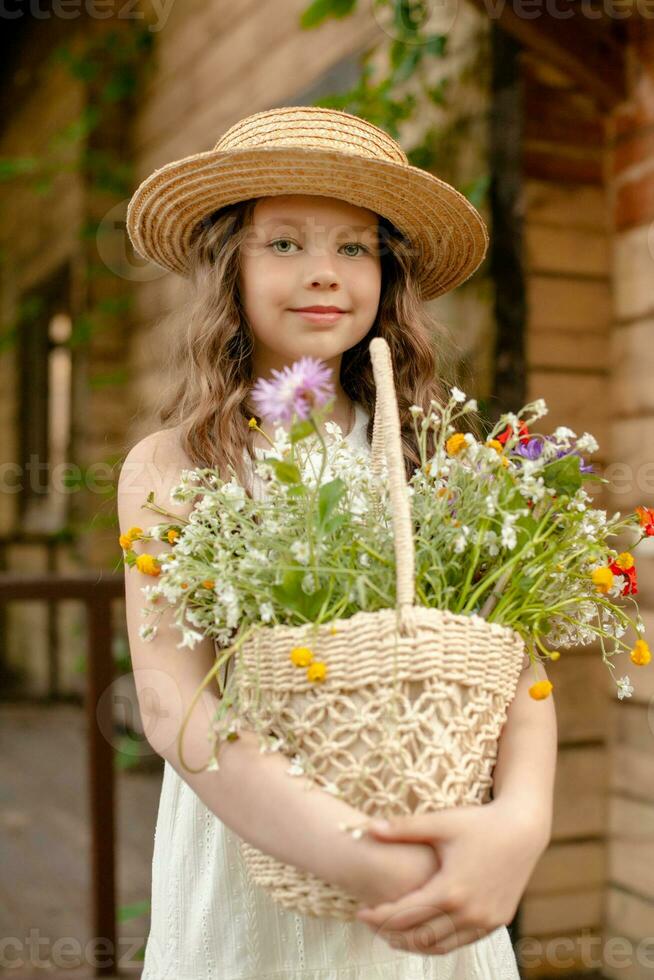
{"left": 368, "top": 337, "right": 415, "bottom": 632}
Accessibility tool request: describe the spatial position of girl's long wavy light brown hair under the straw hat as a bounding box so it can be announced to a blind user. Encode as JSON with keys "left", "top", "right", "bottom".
{"left": 157, "top": 198, "right": 479, "bottom": 495}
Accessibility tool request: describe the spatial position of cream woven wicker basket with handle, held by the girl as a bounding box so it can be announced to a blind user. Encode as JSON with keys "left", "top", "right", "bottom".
{"left": 226, "top": 337, "right": 525, "bottom": 920}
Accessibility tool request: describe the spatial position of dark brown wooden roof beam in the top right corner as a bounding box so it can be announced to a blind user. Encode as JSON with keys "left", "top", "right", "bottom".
{"left": 472, "top": 0, "right": 635, "bottom": 109}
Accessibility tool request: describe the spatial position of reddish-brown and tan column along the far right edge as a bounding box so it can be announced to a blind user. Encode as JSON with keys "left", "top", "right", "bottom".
{"left": 604, "top": 15, "right": 654, "bottom": 980}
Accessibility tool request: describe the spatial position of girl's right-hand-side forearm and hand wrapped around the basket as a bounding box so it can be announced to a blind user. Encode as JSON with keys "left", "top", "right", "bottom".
{"left": 357, "top": 657, "right": 557, "bottom": 954}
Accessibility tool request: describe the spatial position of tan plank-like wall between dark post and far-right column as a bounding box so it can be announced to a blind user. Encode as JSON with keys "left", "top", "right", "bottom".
{"left": 520, "top": 51, "right": 611, "bottom": 977}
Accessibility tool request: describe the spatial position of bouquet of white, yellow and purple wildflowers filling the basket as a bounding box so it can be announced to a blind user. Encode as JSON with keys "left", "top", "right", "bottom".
{"left": 120, "top": 357, "right": 654, "bottom": 772}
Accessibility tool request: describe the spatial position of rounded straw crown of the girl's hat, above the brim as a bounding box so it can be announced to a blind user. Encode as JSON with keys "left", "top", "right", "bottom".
{"left": 214, "top": 106, "right": 409, "bottom": 165}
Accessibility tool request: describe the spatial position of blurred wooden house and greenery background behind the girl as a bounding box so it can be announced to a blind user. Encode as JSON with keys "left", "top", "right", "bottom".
{"left": 0, "top": 0, "right": 654, "bottom": 980}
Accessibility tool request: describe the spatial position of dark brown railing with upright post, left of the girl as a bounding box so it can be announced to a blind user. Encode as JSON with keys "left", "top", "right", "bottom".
{"left": 0, "top": 571, "right": 125, "bottom": 977}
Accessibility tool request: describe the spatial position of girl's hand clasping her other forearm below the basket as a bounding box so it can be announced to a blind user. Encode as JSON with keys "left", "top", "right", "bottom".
{"left": 356, "top": 799, "right": 549, "bottom": 955}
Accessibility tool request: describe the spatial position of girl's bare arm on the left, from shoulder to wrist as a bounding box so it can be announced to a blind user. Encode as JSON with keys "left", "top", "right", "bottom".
{"left": 118, "top": 430, "right": 438, "bottom": 904}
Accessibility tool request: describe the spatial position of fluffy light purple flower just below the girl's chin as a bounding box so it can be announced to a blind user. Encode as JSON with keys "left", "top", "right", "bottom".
{"left": 252, "top": 356, "right": 336, "bottom": 422}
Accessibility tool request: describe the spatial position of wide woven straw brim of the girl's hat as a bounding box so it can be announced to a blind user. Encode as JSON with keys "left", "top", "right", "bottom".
{"left": 127, "top": 147, "right": 488, "bottom": 300}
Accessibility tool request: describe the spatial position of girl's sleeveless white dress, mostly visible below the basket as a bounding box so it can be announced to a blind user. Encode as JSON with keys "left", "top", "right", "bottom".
{"left": 141, "top": 404, "right": 520, "bottom": 980}
